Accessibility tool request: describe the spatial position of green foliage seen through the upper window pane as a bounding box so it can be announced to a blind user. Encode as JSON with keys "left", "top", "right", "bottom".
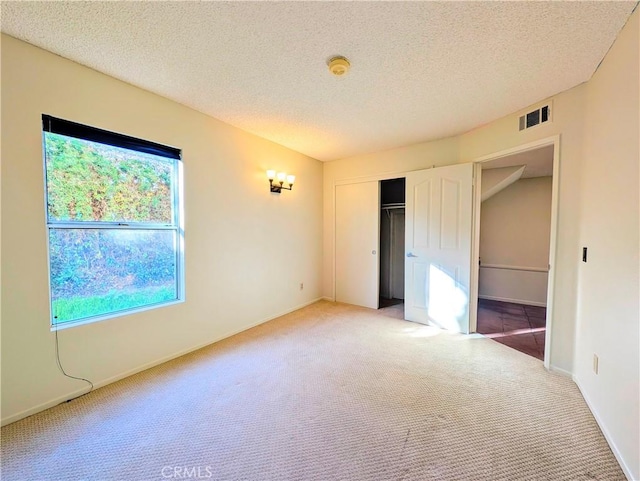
{"left": 45, "top": 133, "right": 173, "bottom": 224}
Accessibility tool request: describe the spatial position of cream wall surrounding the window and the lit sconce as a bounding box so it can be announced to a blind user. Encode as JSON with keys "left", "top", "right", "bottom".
{"left": 1, "top": 35, "right": 322, "bottom": 422}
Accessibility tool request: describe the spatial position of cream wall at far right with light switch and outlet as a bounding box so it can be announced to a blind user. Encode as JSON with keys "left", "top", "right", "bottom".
{"left": 574, "top": 11, "right": 640, "bottom": 480}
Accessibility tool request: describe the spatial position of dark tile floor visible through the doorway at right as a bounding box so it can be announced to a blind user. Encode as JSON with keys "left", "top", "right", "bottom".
{"left": 478, "top": 299, "right": 547, "bottom": 360}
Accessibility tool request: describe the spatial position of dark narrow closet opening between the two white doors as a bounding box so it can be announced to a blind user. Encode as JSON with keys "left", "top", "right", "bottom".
{"left": 379, "top": 178, "right": 406, "bottom": 313}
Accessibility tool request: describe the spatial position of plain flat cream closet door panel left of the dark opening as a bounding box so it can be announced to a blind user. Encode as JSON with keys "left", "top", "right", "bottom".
{"left": 335, "top": 181, "right": 380, "bottom": 309}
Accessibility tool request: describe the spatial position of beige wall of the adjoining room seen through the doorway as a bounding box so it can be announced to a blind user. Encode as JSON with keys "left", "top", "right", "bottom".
{"left": 479, "top": 175, "right": 552, "bottom": 306}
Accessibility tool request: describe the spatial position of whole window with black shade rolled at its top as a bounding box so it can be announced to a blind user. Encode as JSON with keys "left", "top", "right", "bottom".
{"left": 42, "top": 115, "right": 184, "bottom": 327}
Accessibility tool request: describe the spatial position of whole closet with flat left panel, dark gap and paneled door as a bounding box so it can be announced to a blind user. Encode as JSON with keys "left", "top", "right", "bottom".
{"left": 334, "top": 163, "right": 474, "bottom": 332}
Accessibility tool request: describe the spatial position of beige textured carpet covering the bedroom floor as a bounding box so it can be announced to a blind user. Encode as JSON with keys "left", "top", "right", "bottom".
{"left": 2, "top": 302, "right": 624, "bottom": 481}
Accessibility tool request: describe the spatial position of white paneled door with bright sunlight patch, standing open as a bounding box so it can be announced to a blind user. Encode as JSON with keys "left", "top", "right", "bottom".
{"left": 404, "top": 164, "right": 473, "bottom": 333}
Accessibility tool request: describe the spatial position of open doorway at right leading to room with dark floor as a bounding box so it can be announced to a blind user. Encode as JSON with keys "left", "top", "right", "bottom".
{"left": 474, "top": 138, "right": 559, "bottom": 367}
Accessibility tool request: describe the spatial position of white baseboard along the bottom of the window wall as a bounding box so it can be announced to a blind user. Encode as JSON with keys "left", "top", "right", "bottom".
{"left": 0, "top": 297, "right": 324, "bottom": 426}
